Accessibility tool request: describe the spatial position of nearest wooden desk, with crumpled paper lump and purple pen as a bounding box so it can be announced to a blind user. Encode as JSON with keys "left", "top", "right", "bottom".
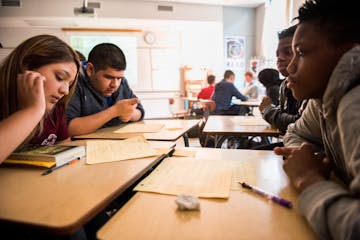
{"left": 97, "top": 148, "right": 316, "bottom": 240}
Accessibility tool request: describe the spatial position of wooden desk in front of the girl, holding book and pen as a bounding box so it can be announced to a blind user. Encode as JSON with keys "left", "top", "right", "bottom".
{"left": 0, "top": 142, "right": 174, "bottom": 235}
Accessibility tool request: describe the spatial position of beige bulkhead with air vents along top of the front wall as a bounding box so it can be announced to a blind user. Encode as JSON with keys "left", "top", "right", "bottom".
{"left": 0, "top": 0, "right": 222, "bottom": 21}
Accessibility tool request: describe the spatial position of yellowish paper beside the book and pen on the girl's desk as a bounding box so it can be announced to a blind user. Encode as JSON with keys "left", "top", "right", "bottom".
{"left": 86, "top": 136, "right": 160, "bottom": 164}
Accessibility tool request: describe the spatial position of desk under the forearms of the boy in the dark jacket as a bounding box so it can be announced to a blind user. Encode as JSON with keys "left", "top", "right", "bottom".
{"left": 73, "top": 119, "right": 200, "bottom": 146}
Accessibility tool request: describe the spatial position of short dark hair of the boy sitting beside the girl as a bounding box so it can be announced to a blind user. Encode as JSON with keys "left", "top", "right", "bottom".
{"left": 88, "top": 43, "right": 126, "bottom": 71}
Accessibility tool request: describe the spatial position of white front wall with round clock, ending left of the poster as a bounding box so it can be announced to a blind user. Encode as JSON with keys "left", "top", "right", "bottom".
{"left": 0, "top": 0, "right": 223, "bottom": 91}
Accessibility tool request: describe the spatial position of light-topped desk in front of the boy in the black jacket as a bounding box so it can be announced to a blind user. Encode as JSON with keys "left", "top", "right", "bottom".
{"left": 203, "top": 115, "right": 281, "bottom": 147}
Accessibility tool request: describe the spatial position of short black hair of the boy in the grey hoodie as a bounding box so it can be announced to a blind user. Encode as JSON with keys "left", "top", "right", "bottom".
{"left": 294, "top": 0, "right": 360, "bottom": 45}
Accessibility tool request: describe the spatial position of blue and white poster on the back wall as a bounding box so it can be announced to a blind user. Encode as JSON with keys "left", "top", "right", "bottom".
{"left": 225, "top": 36, "right": 245, "bottom": 71}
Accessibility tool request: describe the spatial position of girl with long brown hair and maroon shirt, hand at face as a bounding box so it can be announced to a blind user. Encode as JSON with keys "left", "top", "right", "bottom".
{"left": 0, "top": 35, "right": 80, "bottom": 165}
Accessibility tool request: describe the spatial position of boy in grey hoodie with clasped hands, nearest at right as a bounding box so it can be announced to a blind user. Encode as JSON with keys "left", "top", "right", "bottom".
{"left": 275, "top": 0, "right": 360, "bottom": 239}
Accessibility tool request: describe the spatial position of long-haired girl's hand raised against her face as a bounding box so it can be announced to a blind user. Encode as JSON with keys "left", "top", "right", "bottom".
{"left": 17, "top": 71, "right": 46, "bottom": 112}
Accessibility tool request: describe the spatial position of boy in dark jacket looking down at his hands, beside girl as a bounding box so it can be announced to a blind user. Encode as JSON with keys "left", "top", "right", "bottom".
{"left": 66, "top": 43, "right": 145, "bottom": 136}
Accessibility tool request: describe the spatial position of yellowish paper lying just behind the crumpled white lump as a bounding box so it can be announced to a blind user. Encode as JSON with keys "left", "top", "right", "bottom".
{"left": 134, "top": 158, "right": 232, "bottom": 198}
